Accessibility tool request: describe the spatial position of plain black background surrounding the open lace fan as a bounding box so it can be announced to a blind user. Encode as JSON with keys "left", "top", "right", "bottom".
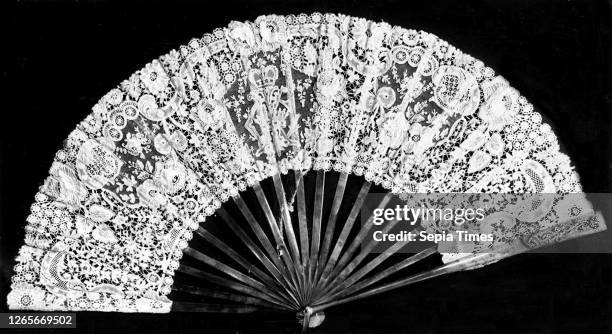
{"left": 0, "top": 0, "right": 612, "bottom": 333}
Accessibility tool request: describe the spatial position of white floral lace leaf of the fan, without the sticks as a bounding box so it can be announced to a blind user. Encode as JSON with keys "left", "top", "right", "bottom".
{"left": 8, "top": 13, "right": 599, "bottom": 312}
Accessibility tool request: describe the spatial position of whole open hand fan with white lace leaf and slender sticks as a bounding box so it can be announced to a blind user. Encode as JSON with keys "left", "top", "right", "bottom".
{"left": 8, "top": 14, "right": 605, "bottom": 327}
